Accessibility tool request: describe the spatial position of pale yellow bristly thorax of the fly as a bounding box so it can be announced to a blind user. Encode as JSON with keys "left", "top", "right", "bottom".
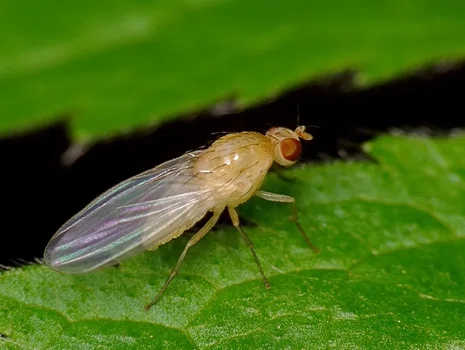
{"left": 194, "top": 132, "right": 273, "bottom": 204}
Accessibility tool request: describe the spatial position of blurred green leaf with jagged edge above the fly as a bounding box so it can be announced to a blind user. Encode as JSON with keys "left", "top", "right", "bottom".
{"left": 0, "top": 0, "right": 465, "bottom": 138}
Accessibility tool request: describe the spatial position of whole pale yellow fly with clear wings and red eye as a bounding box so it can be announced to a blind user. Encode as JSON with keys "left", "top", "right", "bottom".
{"left": 44, "top": 126, "right": 317, "bottom": 310}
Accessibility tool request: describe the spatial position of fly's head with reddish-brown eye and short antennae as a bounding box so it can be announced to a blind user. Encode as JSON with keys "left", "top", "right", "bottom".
{"left": 265, "top": 125, "right": 313, "bottom": 166}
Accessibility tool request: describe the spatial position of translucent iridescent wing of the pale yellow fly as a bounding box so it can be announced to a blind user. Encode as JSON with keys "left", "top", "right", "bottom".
{"left": 45, "top": 151, "right": 211, "bottom": 273}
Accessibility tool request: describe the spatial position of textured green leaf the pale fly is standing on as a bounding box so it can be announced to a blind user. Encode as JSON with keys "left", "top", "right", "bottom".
{"left": 0, "top": 136, "right": 465, "bottom": 349}
